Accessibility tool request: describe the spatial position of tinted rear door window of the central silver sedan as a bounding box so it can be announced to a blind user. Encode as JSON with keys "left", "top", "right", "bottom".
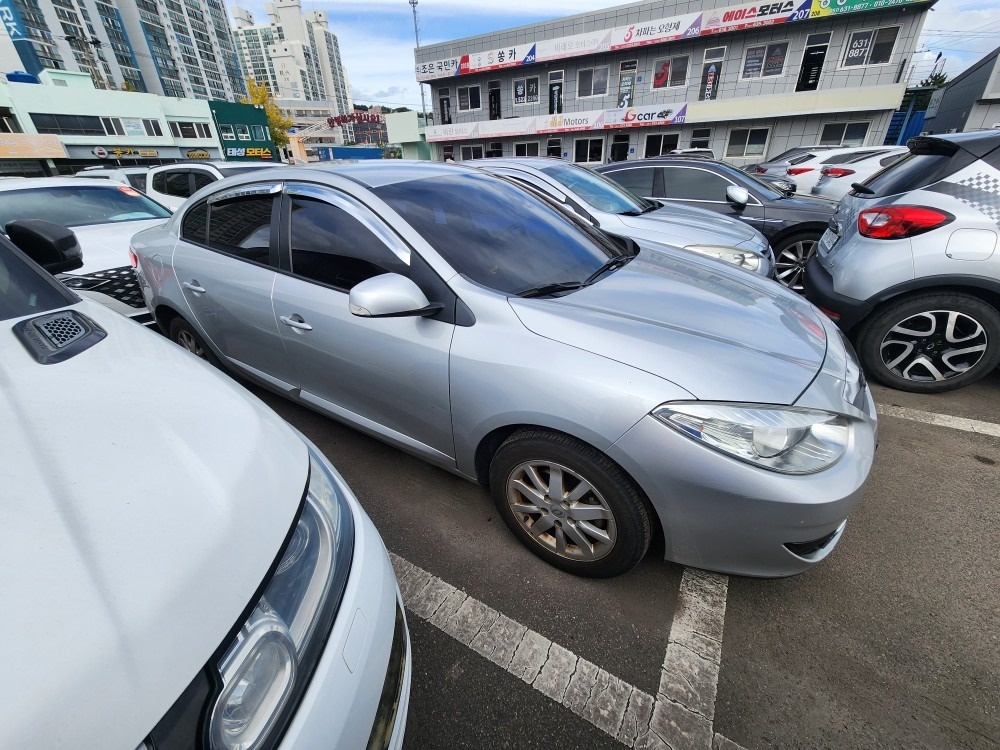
{"left": 208, "top": 194, "right": 274, "bottom": 265}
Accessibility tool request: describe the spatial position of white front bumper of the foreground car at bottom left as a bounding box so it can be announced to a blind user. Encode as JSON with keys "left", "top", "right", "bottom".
{"left": 280, "top": 490, "right": 413, "bottom": 750}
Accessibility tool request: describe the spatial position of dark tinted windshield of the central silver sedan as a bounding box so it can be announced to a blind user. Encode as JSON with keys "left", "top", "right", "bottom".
{"left": 374, "top": 171, "right": 622, "bottom": 294}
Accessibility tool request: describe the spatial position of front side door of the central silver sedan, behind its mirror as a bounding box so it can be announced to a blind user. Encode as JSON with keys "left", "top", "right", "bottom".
{"left": 274, "top": 184, "right": 455, "bottom": 461}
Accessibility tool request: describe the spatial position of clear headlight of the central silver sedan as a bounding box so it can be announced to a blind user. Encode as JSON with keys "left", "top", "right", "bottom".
{"left": 653, "top": 402, "right": 850, "bottom": 474}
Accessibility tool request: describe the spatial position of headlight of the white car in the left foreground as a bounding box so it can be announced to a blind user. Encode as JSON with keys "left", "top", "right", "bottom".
{"left": 209, "top": 448, "right": 354, "bottom": 750}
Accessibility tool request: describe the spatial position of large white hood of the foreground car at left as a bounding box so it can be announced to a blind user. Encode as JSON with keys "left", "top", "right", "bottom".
{"left": 0, "top": 301, "right": 308, "bottom": 748}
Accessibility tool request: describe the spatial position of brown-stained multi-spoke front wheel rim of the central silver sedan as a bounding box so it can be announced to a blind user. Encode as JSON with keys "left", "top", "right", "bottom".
{"left": 507, "top": 461, "right": 618, "bottom": 562}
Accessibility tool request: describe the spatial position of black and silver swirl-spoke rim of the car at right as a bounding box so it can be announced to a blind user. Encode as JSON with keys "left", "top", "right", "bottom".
{"left": 879, "top": 310, "right": 989, "bottom": 382}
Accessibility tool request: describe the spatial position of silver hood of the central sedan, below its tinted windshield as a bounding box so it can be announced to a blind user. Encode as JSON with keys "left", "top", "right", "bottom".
{"left": 511, "top": 249, "right": 826, "bottom": 404}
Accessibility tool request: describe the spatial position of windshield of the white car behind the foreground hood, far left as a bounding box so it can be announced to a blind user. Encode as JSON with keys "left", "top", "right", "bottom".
{"left": 0, "top": 180, "right": 170, "bottom": 232}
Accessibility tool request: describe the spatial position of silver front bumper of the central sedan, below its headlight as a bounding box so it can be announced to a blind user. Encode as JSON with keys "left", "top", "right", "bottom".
{"left": 607, "top": 389, "right": 877, "bottom": 577}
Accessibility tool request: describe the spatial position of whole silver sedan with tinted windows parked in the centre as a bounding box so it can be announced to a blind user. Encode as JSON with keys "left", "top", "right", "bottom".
{"left": 133, "top": 161, "right": 876, "bottom": 577}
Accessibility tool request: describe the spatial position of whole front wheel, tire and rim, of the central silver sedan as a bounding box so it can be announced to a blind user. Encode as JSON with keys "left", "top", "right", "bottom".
{"left": 490, "top": 430, "right": 651, "bottom": 578}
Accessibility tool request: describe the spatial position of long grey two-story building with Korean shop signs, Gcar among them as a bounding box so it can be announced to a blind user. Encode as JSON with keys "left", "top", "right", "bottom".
{"left": 415, "top": 0, "right": 933, "bottom": 165}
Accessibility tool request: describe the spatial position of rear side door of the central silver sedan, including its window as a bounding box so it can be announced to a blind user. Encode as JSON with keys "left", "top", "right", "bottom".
{"left": 173, "top": 182, "right": 294, "bottom": 390}
